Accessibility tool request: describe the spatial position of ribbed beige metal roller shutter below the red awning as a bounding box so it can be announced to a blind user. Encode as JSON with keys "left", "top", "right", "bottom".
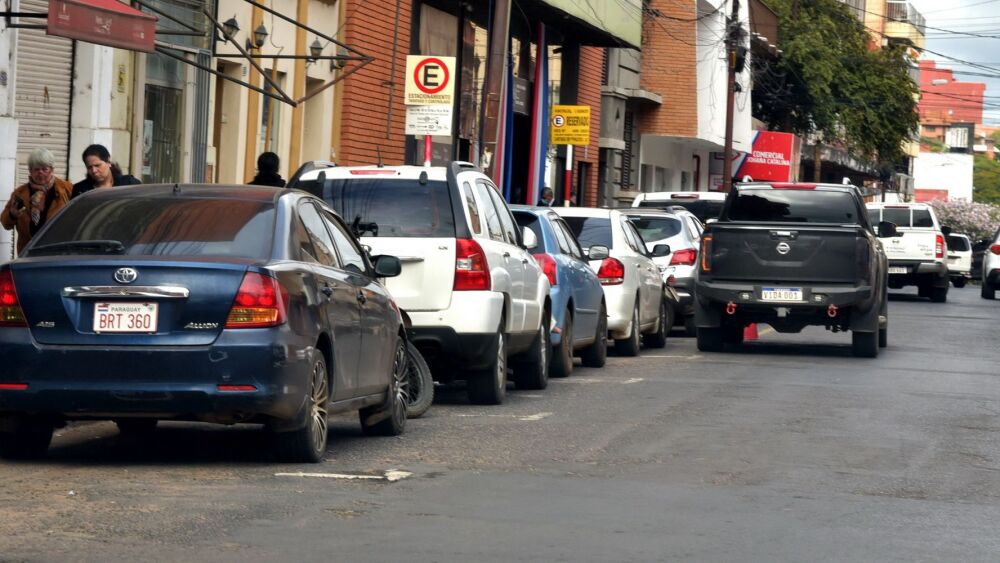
{"left": 14, "top": 0, "right": 73, "bottom": 185}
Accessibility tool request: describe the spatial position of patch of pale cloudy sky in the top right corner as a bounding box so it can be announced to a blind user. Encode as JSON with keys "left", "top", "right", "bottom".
{"left": 910, "top": 0, "right": 1000, "bottom": 125}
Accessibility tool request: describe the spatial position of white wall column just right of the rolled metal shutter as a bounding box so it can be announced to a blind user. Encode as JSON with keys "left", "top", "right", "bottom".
{"left": 68, "top": 41, "right": 116, "bottom": 181}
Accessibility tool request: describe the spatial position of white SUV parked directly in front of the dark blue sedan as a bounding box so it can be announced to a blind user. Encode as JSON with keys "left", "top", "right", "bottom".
{"left": 290, "top": 162, "right": 551, "bottom": 404}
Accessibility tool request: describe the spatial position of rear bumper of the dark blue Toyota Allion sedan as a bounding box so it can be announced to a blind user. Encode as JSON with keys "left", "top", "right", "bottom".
{"left": 0, "top": 329, "right": 311, "bottom": 423}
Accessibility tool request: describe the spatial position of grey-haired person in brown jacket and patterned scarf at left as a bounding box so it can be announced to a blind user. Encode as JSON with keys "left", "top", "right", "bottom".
{"left": 0, "top": 149, "right": 73, "bottom": 253}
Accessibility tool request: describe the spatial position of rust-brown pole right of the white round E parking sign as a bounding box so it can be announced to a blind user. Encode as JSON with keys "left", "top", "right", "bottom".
{"left": 479, "top": 0, "right": 510, "bottom": 182}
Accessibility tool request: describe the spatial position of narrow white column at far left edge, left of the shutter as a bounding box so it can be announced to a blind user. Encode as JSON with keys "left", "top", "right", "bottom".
{"left": 0, "top": 12, "right": 17, "bottom": 262}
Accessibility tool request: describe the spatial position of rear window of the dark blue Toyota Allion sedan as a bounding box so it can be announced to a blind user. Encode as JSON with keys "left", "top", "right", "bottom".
{"left": 24, "top": 197, "right": 275, "bottom": 259}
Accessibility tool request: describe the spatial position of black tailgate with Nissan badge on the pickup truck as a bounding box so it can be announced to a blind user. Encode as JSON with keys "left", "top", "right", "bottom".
{"left": 706, "top": 223, "right": 869, "bottom": 284}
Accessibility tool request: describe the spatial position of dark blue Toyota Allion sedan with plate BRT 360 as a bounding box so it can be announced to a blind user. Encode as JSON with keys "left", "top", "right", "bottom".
{"left": 0, "top": 185, "right": 406, "bottom": 462}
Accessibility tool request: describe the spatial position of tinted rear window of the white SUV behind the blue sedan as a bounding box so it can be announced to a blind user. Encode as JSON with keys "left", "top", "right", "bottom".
{"left": 298, "top": 176, "right": 455, "bottom": 238}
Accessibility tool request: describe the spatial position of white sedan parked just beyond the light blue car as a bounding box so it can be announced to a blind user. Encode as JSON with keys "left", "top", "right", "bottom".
{"left": 553, "top": 207, "right": 670, "bottom": 356}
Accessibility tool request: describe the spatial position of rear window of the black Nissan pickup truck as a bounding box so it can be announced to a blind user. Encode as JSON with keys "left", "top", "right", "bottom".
{"left": 728, "top": 188, "right": 860, "bottom": 224}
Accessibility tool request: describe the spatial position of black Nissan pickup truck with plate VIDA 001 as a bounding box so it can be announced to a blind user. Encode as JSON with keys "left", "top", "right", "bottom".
{"left": 695, "top": 183, "right": 896, "bottom": 358}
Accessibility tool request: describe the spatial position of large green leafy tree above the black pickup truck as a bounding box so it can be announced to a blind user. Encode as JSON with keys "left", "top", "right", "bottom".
{"left": 754, "top": 0, "right": 919, "bottom": 176}
